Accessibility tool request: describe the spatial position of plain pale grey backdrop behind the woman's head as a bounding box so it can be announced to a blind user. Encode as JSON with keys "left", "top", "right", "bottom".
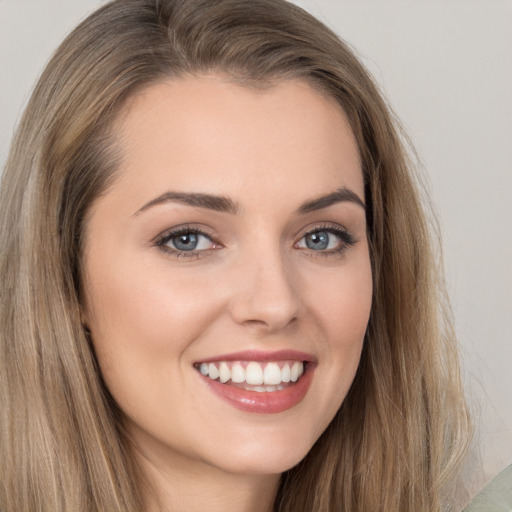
{"left": 0, "top": 0, "right": 512, "bottom": 492}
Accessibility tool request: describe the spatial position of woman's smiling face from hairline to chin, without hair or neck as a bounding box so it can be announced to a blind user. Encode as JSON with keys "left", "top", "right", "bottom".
{"left": 84, "top": 76, "right": 372, "bottom": 474}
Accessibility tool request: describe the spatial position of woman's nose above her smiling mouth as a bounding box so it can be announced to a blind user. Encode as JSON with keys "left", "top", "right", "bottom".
{"left": 230, "top": 247, "right": 301, "bottom": 333}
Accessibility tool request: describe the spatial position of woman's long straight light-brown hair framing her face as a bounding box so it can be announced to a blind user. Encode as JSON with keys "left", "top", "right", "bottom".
{"left": 0, "top": 0, "right": 469, "bottom": 512}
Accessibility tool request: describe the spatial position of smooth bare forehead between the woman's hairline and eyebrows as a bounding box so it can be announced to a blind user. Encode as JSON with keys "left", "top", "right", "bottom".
{"left": 109, "top": 76, "right": 363, "bottom": 212}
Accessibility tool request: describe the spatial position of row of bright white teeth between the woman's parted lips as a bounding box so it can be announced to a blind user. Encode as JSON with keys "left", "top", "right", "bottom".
{"left": 194, "top": 360, "right": 307, "bottom": 393}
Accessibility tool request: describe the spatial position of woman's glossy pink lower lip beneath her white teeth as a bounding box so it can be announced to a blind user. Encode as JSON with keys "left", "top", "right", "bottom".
{"left": 199, "top": 363, "right": 314, "bottom": 414}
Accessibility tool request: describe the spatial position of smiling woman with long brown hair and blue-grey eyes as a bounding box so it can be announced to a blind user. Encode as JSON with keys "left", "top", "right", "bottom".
{"left": 0, "top": 0, "right": 469, "bottom": 512}
